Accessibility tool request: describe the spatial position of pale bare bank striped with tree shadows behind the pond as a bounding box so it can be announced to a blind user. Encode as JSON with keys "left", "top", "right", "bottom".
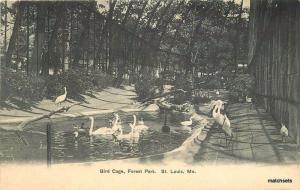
{"left": 0, "top": 86, "right": 157, "bottom": 126}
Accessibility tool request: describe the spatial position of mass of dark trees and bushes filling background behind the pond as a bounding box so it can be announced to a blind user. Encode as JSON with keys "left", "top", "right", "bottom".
{"left": 0, "top": 0, "right": 249, "bottom": 103}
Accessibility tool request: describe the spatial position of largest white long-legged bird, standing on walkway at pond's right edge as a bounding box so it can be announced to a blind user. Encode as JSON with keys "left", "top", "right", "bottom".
{"left": 212, "top": 102, "right": 233, "bottom": 146}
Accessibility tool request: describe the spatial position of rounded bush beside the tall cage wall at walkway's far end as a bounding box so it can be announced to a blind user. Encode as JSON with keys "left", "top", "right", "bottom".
{"left": 228, "top": 74, "right": 254, "bottom": 100}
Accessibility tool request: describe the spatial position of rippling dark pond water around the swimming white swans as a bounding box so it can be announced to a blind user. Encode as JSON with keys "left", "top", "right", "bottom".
{"left": 0, "top": 112, "right": 190, "bottom": 163}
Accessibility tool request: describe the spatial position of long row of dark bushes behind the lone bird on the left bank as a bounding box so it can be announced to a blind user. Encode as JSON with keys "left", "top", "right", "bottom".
{"left": 2, "top": 68, "right": 112, "bottom": 101}
